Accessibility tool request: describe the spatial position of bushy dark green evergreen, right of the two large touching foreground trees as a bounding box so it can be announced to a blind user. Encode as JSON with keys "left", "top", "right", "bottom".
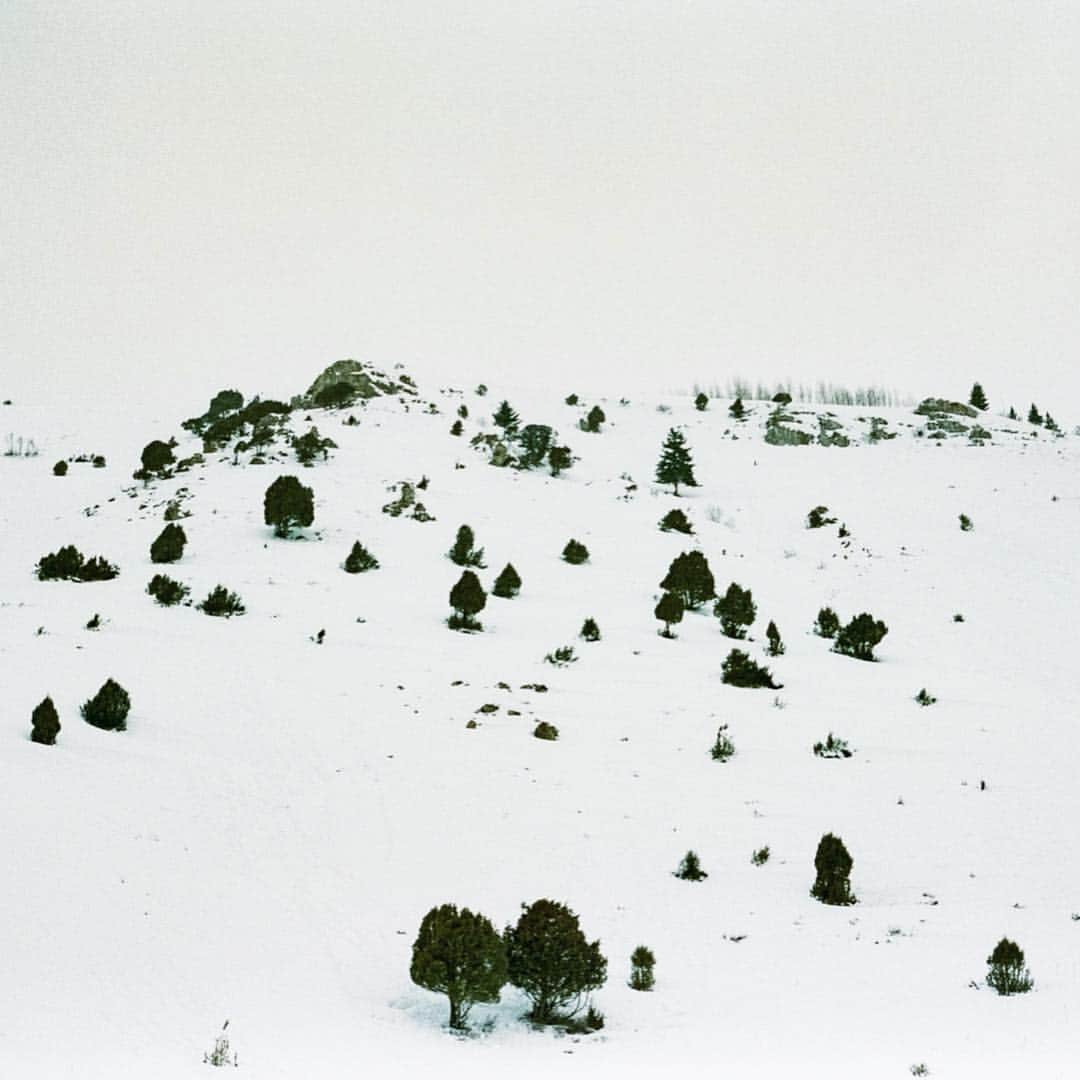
{"left": 503, "top": 900, "right": 607, "bottom": 1024}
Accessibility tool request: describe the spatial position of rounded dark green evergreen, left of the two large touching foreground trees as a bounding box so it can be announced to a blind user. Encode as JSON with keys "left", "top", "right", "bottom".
{"left": 409, "top": 904, "right": 507, "bottom": 1030}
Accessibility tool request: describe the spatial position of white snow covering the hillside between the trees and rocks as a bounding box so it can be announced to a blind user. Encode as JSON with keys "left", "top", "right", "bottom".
{"left": 0, "top": 386, "right": 1080, "bottom": 1080}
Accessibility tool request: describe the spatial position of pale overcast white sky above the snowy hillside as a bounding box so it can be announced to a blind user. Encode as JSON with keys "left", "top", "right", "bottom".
{"left": 0, "top": 0, "right": 1080, "bottom": 420}
